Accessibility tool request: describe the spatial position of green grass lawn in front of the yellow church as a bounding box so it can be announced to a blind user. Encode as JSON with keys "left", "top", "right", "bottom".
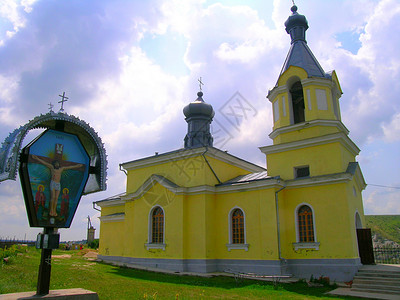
{"left": 0, "top": 247, "right": 356, "bottom": 300}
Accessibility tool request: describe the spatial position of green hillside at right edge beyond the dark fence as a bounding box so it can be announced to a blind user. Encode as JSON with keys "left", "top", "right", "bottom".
{"left": 365, "top": 215, "right": 400, "bottom": 243}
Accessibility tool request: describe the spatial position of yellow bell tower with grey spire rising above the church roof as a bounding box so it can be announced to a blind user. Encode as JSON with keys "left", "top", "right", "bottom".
{"left": 260, "top": 5, "right": 360, "bottom": 180}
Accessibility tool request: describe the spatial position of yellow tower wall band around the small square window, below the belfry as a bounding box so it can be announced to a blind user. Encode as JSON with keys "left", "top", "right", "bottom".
{"left": 267, "top": 142, "right": 348, "bottom": 180}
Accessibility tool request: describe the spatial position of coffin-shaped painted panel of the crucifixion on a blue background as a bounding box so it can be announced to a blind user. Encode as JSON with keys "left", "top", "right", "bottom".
{"left": 23, "top": 130, "right": 89, "bottom": 228}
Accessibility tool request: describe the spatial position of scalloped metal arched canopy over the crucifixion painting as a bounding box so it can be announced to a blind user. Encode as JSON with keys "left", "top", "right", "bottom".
{"left": 0, "top": 111, "right": 107, "bottom": 194}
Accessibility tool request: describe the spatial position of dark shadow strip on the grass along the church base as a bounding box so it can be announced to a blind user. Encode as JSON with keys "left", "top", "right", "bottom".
{"left": 103, "top": 267, "right": 355, "bottom": 299}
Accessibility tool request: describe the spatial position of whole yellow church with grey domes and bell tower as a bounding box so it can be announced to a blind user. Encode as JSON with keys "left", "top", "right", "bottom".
{"left": 95, "top": 6, "right": 366, "bottom": 281}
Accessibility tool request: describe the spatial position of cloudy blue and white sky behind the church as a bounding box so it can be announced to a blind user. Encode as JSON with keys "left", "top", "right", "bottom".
{"left": 0, "top": 0, "right": 400, "bottom": 241}
